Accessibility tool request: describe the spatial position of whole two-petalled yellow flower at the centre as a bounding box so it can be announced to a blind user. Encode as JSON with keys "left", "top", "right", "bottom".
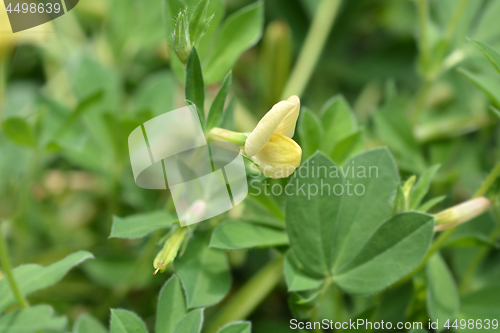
{"left": 244, "top": 96, "right": 302, "bottom": 178}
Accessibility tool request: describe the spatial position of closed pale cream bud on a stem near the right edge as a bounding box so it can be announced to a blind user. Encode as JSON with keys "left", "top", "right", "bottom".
{"left": 434, "top": 197, "right": 491, "bottom": 231}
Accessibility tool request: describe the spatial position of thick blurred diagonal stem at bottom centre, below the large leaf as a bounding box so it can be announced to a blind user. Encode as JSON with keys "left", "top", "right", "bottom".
{"left": 207, "top": 256, "right": 284, "bottom": 333}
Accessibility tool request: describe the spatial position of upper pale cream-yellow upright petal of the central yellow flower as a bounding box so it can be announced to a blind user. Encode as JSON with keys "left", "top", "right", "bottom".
{"left": 245, "top": 96, "right": 300, "bottom": 156}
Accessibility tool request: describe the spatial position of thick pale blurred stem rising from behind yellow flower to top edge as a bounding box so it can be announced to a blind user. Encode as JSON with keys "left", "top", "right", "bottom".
{"left": 282, "top": 0, "right": 341, "bottom": 99}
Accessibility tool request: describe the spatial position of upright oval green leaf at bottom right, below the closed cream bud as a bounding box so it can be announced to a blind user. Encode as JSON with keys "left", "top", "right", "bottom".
{"left": 427, "top": 254, "right": 460, "bottom": 331}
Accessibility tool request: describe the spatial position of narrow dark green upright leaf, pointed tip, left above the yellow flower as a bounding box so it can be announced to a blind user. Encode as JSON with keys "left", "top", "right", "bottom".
{"left": 186, "top": 47, "right": 205, "bottom": 124}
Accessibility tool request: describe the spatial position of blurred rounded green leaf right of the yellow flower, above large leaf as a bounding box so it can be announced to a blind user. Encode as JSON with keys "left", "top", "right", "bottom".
{"left": 320, "top": 95, "right": 358, "bottom": 154}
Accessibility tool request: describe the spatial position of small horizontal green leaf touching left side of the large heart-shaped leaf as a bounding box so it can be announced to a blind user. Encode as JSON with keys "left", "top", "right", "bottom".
{"left": 210, "top": 221, "right": 288, "bottom": 250}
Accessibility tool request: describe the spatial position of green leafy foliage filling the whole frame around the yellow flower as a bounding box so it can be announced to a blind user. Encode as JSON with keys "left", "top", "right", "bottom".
{"left": 0, "top": 0, "right": 500, "bottom": 333}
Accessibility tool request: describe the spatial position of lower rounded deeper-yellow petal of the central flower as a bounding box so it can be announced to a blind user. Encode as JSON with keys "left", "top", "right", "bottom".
{"left": 253, "top": 133, "right": 302, "bottom": 179}
